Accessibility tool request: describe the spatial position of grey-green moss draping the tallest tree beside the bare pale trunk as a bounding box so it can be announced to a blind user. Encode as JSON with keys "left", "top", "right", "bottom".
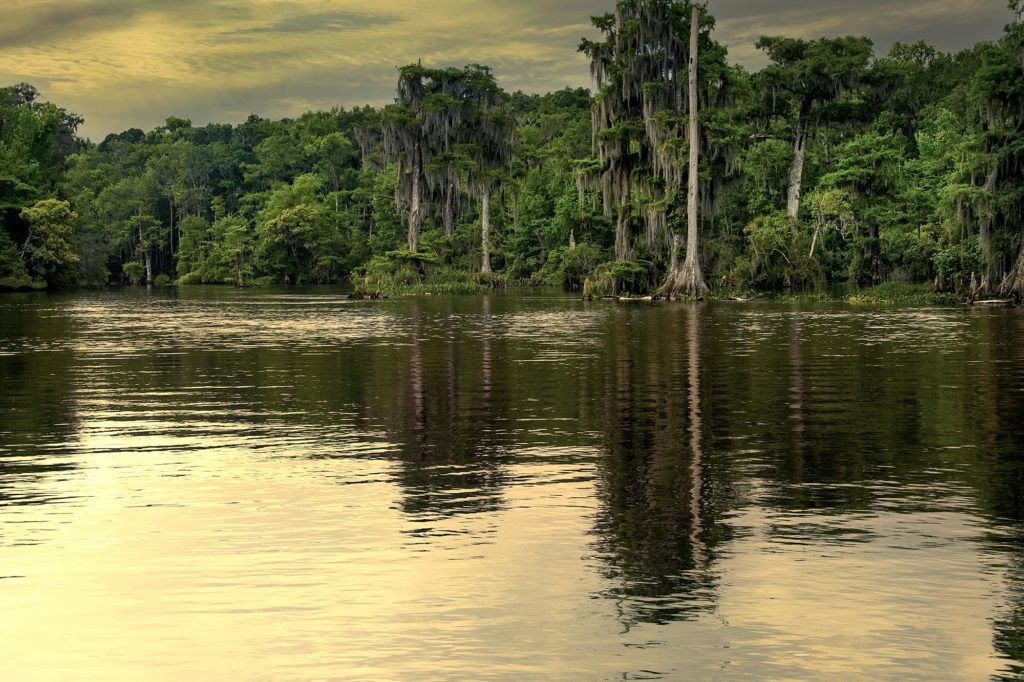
{"left": 579, "top": 0, "right": 744, "bottom": 274}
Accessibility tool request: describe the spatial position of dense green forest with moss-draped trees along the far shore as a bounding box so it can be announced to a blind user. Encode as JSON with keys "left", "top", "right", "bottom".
{"left": 0, "top": 0, "right": 1024, "bottom": 299}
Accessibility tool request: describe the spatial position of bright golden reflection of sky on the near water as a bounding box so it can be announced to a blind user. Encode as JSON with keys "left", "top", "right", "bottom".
{"left": 0, "top": 432, "right": 1004, "bottom": 680}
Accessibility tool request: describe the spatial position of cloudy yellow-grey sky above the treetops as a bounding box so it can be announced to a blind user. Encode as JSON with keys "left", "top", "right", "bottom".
{"left": 0, "top": 0, "right": 1011, "bottom": 140}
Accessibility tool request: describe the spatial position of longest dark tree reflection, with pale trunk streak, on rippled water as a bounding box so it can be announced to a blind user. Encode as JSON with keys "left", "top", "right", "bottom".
{"left": 597, "top": 306, "right": 727, "bottom": 627}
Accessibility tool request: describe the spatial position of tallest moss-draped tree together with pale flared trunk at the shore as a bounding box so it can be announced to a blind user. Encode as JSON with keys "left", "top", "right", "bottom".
{"left": 580, "top": 0, "right": 736, "bottom": 297}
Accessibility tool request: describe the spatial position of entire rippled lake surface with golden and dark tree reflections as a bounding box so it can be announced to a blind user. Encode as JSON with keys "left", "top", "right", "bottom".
{"left": 0, "top": 289, "right": 1024, "bottom": 680}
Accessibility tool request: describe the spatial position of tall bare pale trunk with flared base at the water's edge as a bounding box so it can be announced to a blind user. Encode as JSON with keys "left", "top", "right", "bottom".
{"left": 658, "top": 3, "right": 708, "bottom": 299}
